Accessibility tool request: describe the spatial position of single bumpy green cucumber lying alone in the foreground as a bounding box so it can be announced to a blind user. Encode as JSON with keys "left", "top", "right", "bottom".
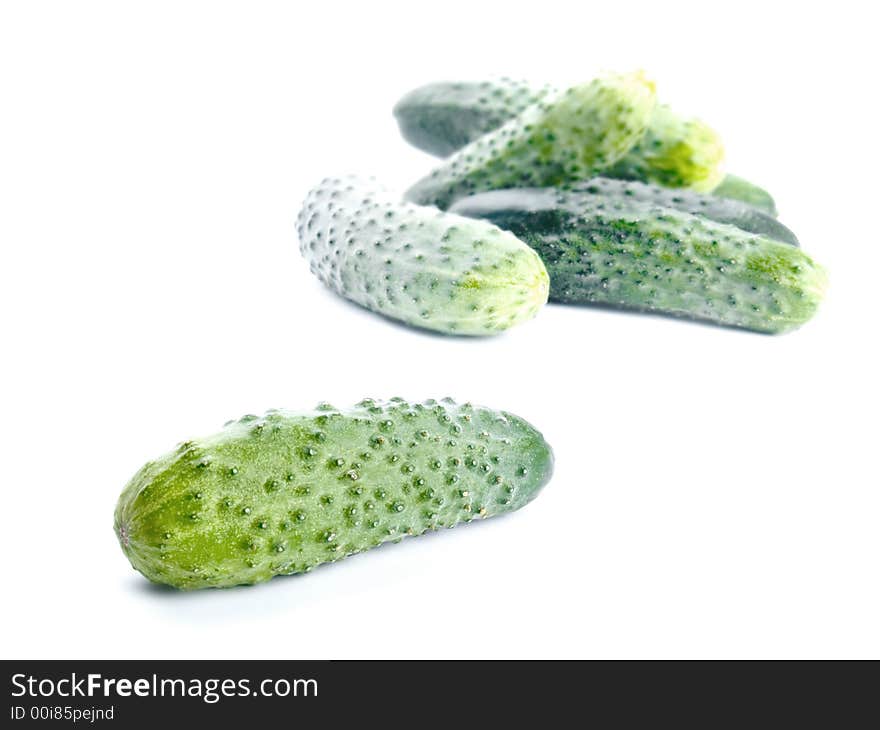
{"left": 114, "top": 398, "right": 553, "bottom": 590}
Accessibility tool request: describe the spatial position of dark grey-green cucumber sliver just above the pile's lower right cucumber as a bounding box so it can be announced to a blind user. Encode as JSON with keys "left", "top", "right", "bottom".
{"left": 560, "top": 177, "right": 799, "bottom": 246}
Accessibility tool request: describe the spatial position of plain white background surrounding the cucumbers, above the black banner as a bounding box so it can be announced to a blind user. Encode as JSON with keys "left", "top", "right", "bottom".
{"left": 0, "top": 0, "right": 880, "bottom": 658}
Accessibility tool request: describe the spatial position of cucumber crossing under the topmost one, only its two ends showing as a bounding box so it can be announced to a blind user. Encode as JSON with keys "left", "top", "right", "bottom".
{"left": 394, "top": 79, "right": 724, "bottom": 191}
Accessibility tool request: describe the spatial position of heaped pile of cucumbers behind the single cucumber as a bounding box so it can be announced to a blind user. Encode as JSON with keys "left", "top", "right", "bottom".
{"left": 298, "top": 72, "right": 826, "bottom": 335}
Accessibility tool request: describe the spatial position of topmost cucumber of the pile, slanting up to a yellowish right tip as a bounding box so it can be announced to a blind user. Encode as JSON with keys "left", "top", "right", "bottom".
{"left": 406, "top": 73, "right": 655, "bottom": 208}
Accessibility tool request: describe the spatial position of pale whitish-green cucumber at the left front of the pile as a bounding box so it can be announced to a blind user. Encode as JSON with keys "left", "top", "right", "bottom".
{"left": 297, "top": 178, "right": 550, "bottom": 335}
